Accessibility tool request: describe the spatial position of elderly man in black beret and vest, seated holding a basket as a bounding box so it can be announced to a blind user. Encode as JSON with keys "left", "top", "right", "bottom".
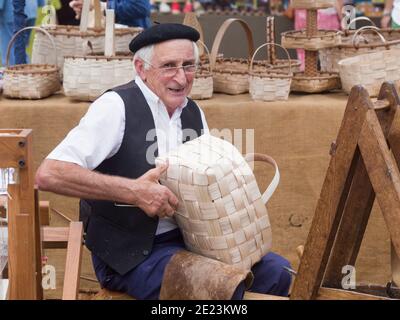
{"left": 36, "top": 24, "right": 290, "bottom": 299}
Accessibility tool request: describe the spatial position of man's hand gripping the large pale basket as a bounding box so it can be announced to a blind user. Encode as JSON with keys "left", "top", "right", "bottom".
{"left": 136, "top": 165, "right": 179, "bottom": 218}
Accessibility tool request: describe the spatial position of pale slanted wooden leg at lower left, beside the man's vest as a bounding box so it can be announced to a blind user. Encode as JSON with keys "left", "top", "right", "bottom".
{"left": 62, "top": 222, "right": 83, "bottom": 300}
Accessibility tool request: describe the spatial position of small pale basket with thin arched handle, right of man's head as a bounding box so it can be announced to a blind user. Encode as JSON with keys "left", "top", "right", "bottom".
{"left": 249, "top": 43, "right": 293, "bottom": 101}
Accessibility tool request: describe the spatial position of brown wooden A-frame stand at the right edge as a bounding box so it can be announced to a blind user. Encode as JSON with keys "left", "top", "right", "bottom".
{"left": 290, "top": 83, "right": 400, "bottom": 299}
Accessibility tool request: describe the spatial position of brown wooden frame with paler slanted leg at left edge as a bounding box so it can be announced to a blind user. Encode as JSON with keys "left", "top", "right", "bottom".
{"left": 0, "top": 129, "right": 83, "bottom": 300}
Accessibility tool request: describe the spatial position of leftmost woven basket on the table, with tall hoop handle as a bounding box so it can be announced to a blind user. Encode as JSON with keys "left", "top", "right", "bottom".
{"left": 3, "top": 27, "right": 61, "bottom": 99}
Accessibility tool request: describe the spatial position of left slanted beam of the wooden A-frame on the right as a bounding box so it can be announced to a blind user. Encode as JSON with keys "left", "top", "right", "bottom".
{"left": 291, "top": 86, "right": 373, "bottom": 300}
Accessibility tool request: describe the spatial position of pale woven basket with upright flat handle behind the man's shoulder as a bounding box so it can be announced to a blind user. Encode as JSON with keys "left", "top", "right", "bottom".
{"left": 63, "top": 10, "right": 136, "bottom": 101}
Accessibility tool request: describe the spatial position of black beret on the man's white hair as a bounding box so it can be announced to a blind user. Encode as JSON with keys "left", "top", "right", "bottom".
{"left": 129, "top": 23, "right": 200, "bottom": 53}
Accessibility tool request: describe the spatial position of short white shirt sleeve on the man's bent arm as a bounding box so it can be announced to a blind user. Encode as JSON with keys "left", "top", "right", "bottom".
{"left": 47, "top": 91, "right": 125, "bottom": 170}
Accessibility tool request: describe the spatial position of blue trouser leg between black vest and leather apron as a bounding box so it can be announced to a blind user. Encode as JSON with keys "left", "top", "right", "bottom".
{"left": 92, "top": 229, "right": 185, "bottom": 300}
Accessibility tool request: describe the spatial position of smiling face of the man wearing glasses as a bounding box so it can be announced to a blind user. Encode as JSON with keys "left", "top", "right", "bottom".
{"left": 139, "top": 39, "right": 195, "bottom": 114}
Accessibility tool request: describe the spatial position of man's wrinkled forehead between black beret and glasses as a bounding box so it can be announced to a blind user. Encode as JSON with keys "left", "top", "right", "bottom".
{"left": 153, "top": 39, "right": 195, "bottom": 62}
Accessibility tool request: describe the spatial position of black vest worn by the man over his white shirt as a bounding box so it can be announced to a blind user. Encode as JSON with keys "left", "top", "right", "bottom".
{"left": 80, "top": 81, "right": 203, "bottom": 275}
